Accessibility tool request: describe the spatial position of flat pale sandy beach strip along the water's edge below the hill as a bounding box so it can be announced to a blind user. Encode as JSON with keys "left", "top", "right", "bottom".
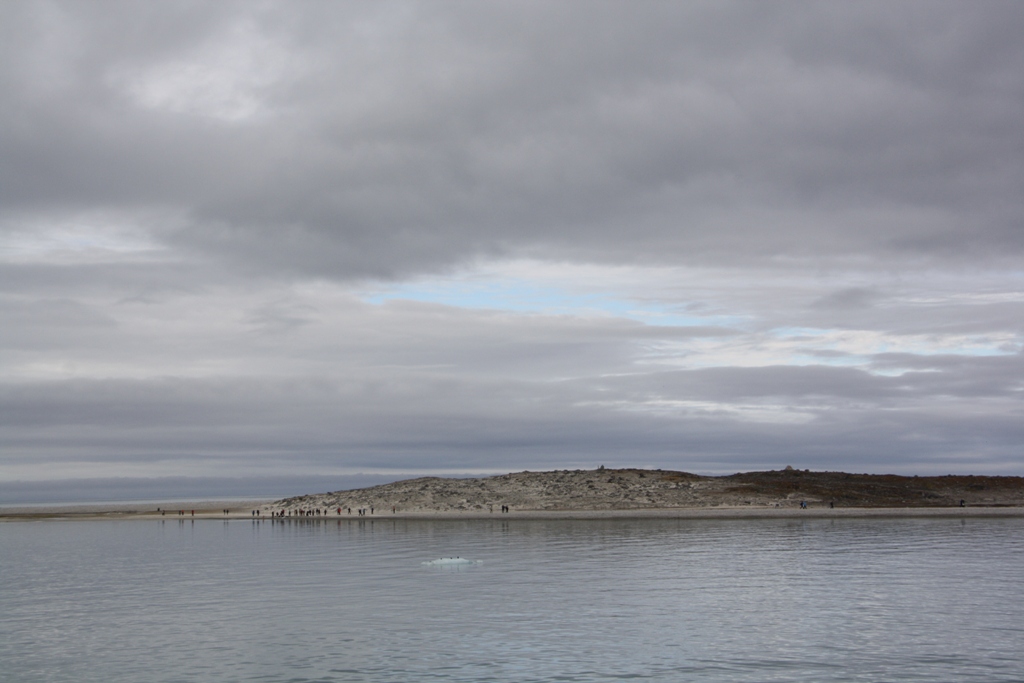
{"left": 0, "top": 501, "right": 1024, "bottom": 524}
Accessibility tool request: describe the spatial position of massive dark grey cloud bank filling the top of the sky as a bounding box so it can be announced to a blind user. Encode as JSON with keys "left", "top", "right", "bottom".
{"left": 0, "top": 3, "right": 1024, "bottom": 278}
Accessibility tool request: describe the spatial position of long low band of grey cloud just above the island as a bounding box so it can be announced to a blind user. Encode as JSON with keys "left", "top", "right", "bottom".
{"left": 0, "top": 350, "right": 1022, "bottom": 479}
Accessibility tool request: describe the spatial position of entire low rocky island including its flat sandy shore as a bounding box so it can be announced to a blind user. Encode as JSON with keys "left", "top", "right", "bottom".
{"left": 0, "top": 467, "right": 1024, "bottom": 521}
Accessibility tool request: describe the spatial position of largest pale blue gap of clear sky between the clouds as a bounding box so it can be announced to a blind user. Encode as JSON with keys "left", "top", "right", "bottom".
{"left": 361, "top": 280, "right": 742, "bottom": 327}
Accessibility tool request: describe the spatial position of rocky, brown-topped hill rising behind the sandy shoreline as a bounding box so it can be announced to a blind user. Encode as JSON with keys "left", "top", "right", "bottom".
{"left": 265, "top": 468, "right": 1024, "bottom": 512}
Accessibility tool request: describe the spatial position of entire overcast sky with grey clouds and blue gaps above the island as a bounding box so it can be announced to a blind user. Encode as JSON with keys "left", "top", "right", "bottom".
{"left": 0, "top": 0, "right": 1024, "bottom": 493}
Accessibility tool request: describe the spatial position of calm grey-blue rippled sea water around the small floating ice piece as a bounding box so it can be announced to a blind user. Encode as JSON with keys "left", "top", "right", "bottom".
{"left": 0, "top": 519, "right": 1024, "bottom": 683}
